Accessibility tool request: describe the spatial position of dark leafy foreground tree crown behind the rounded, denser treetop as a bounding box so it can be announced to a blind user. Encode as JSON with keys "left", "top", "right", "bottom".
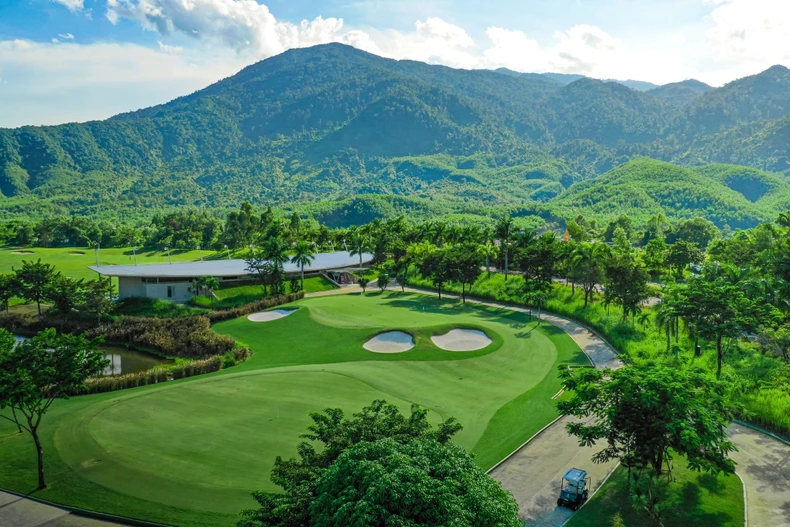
{"left": 239, "top": 400, "right": 464, "bottom": 527}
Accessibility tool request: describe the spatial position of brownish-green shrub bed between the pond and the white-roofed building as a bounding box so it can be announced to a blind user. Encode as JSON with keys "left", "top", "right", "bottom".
{"left": 88, "top": 316, "right": 236, "bottom": 359}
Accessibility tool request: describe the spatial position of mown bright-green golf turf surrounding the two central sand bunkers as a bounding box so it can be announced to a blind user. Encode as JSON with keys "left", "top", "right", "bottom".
{"left": 0, "top": 292, "right": 589, "bottom": 525}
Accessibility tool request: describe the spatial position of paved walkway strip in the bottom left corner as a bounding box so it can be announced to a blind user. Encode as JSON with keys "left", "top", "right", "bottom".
{"left": 0, "top": 491, "right": 121, "bottom": 527}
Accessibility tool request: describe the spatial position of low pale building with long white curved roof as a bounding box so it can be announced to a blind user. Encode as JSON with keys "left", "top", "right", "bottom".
{"left": 89, "top": 251, "right": 373, "bottom": 302}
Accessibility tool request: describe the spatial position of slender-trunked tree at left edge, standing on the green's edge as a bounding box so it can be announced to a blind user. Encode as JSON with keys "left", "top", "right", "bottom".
{"left": 0, "top": 329, "right": 107, "bottom": 490}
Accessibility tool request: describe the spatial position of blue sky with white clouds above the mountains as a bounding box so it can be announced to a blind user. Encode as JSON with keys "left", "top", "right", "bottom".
{"left": 0, "top": 0, "right": 790, "bottom": 127}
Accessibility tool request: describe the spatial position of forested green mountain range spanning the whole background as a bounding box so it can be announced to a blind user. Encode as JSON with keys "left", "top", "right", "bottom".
{"left": 0, "top": 44, "right": 790, "bottom": 226}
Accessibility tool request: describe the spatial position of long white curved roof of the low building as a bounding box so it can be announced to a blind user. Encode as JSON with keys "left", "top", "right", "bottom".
{"left": 88, "top": 251, "right": 373, "bottom": 278}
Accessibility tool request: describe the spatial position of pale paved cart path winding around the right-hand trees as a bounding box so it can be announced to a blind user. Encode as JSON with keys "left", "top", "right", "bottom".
{"left": 407, "top": 288, "right": 790, "bottom": 527}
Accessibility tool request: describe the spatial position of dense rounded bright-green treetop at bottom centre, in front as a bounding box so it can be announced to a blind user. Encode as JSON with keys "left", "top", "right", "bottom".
{"left": 310, "top": 438, "right": 523, "bottom": 527}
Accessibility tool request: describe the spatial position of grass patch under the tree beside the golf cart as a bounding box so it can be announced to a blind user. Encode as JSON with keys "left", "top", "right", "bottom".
{"left": 566, "top": 459, "right": 744, "bottom": 527}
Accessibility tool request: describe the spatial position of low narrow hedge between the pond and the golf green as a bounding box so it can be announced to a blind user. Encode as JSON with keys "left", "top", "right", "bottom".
{"left": 84, "top": 348, "right": 252, "bottom": 393}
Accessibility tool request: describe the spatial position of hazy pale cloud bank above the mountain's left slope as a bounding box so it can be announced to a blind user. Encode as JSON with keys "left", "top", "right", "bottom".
{"left": 0, "top": 40, "right": 246, "bottom": 127}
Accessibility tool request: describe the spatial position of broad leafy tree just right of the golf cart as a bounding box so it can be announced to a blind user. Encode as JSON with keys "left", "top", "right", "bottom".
{"left": 557, "top": 365, "right": 735, "bottom": 475}
